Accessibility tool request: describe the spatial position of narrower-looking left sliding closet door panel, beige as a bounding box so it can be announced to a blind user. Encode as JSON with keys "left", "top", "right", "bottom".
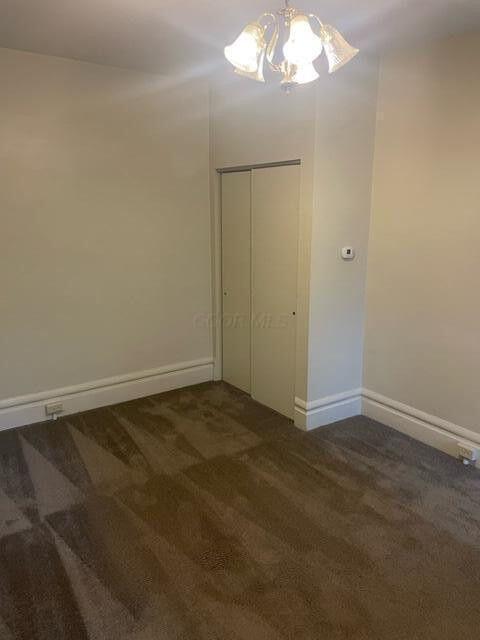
{"left": 222, "top": 171, "right": 251, "bottom": 393}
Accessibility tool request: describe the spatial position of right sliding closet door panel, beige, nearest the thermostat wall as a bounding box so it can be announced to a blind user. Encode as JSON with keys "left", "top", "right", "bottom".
{"left": 251, "top": 166, "right": 300, "bottom": 418}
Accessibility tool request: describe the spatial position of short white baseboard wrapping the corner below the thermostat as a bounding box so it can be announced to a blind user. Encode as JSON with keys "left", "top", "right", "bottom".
{"left": 295, "top": 389, "right": 362, "bottom": 431}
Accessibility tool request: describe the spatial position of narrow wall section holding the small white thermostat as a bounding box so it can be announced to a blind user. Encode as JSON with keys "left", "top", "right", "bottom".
{"left": 308, "top": 54, "right": 378, "bottom": 405}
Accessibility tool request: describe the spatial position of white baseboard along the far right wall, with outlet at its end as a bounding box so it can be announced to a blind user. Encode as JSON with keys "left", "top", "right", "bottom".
{"left": 362, "top": 389, "right": 480, "bottom": 466}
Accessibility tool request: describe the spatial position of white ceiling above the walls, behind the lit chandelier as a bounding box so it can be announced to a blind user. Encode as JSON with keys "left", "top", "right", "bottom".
{"left": 0, "top": 0, "right": 480, "bottom": 74}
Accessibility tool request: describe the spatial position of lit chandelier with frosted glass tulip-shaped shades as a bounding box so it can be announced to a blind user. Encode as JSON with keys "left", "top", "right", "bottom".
{"left": 225, "top": 0, "right": 358, "bottom": 93}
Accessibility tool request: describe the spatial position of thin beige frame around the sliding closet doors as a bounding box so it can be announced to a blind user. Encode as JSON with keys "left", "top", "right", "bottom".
{"left": 211, "top": 159, "right": 307, "bottom": 418}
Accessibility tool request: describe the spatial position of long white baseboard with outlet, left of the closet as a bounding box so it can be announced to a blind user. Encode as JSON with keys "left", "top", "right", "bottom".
{"left": 0, "top": 358, "right": 214, "bottom": 430}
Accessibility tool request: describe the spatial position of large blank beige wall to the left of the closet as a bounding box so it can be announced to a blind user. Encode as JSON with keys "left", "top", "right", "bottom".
{"left": 0, "top": 49, "right": 212, "bottom": 399}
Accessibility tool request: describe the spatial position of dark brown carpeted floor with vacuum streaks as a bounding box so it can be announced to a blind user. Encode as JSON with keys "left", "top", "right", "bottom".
{"left": 0, "top": 383, "right": 480, "bottom": 640}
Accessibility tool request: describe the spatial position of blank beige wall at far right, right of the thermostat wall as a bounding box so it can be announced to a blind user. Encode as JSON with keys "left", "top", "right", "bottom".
{"left": 364, "top": 34, "right": 480, "bottom": 433}
